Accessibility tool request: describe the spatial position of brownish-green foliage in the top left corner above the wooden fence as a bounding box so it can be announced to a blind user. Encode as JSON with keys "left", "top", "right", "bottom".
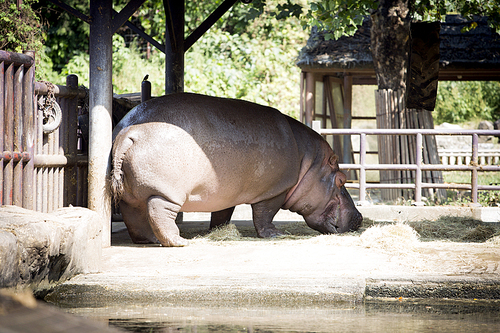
{"left": 0, "top": 0, "right": 43, "bottom": 53}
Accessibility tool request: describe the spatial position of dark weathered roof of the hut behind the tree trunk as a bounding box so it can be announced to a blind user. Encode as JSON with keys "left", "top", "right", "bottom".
{"left": 297, "top": 15, "right": 500, "bottom": 80}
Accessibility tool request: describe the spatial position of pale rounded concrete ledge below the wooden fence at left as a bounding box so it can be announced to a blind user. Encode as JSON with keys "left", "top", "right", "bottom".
{"left": 0, "top": 206, "right": 102, "bottom": 291}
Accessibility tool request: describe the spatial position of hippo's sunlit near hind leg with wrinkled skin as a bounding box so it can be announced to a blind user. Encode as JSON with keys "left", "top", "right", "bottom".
{"left": 148, "top": 195, "right": 189, "bottom": 246}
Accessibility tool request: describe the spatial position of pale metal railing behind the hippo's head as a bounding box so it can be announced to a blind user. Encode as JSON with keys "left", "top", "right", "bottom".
{"left": 313, "top": 121, "right": 500, "bottom": 206}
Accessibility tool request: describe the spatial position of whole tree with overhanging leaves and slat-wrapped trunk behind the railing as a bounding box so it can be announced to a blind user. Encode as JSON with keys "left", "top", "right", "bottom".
{"left": 302, "top": 0, "right": 500, "bottom": 199}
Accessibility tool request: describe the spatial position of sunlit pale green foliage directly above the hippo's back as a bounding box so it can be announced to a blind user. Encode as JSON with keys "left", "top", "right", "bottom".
{"left": 185, "top": 13, "right": 307, "bottom": 117}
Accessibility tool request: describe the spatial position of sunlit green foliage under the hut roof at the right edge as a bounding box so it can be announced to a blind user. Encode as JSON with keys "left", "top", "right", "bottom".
{"left": 433, "top": 81, "right": 500, "bottom": 124}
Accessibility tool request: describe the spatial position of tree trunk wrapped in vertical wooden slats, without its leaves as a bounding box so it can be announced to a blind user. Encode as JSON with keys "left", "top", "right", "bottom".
{"left": 371, "top": 0, "right": 411, "bottom": 201}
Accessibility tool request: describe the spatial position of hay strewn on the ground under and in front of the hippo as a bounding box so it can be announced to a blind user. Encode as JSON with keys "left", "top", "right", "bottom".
{"left": 181, "top": 217, "right": 500, "bottom": 244}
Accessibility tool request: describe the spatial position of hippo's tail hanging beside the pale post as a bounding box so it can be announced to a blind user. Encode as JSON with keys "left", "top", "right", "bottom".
{"left": 109, "top": 133, "right": 134, "bottom": 206}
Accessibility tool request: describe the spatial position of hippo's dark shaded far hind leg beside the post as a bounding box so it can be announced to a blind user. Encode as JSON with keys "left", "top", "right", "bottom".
{"left": 120, "top": 201, "right": 159, "bottom": 244}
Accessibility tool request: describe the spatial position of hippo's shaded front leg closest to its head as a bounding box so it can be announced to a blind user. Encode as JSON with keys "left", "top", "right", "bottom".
{"left": 252, "top": 194, "right": 285, "bottom": 238}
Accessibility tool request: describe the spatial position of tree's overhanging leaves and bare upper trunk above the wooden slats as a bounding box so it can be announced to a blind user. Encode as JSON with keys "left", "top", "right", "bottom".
{"left": 306, "top": 0, "right": 500, "bottom": 101}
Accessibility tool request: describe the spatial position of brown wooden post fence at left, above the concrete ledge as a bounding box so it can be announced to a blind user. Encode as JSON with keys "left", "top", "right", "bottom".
{"left": 0, "top": 50, "right": 87, "bottom": 212}
